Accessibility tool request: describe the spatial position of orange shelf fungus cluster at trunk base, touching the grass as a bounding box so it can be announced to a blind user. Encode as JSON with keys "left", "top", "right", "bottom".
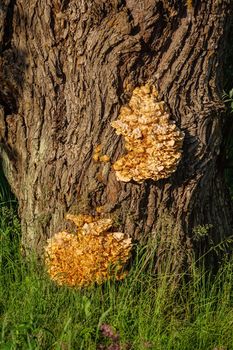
{"left": 45, "top": 215, "right": 132, "bottom": 287}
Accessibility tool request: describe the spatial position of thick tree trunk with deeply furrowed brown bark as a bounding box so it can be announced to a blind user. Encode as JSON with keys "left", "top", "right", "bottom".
{"left": 0, "top": 0, "right": 233, "bottom": 266}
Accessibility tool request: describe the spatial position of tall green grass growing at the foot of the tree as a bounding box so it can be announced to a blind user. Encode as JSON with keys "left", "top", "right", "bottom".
{"left": 0, "top": 207, "right": 233, "bottom": 350}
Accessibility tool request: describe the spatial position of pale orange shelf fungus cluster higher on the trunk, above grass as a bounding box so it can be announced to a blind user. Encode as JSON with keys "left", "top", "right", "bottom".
{"left": 111, "top": 84, "right": 184, "bottom": 183}
